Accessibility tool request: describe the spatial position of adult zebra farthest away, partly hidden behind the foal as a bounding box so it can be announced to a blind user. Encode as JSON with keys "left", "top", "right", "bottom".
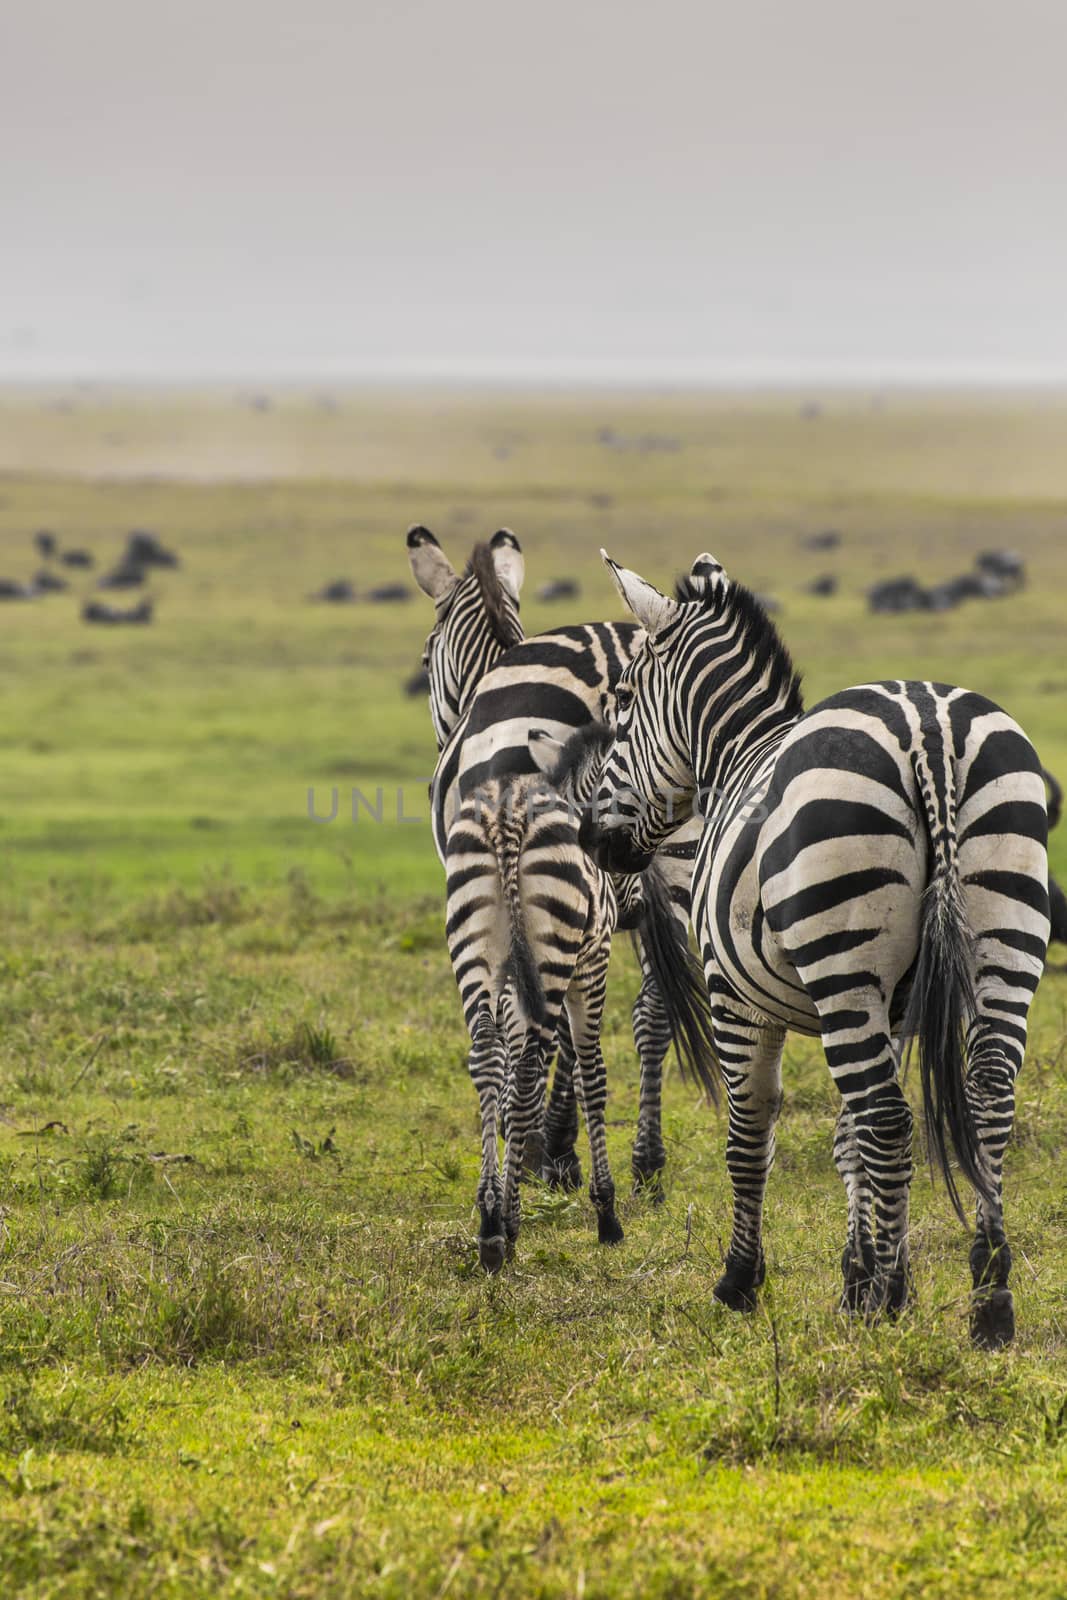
{"left": 406, "top": 525, "right": 717, "bottom": 1202}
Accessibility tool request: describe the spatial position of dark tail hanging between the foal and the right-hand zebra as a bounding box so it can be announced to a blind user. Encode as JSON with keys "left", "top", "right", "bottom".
{"left": 633, "top": 861, "right": 721, "bottom": 1106}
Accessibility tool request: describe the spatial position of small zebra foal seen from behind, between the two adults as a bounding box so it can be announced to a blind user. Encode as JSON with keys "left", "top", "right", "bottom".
{"left": 445, "top": 723, "right": 713, "bottom": 1272}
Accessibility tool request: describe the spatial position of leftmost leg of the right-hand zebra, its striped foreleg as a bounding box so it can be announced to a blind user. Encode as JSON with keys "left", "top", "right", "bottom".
{"left": 712, "top": 1008, "right": 785, "bottom": 1310}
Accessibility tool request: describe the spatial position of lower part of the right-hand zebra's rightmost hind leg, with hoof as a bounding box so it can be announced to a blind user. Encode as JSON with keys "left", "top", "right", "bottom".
{"left": 966, "top": 1016, "right": 1016, "bottom": 1350}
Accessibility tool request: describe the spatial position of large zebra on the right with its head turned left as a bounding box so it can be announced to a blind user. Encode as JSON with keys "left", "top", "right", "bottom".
{"left": 582, "top": 552, "right": 1049, "bottom": 1347}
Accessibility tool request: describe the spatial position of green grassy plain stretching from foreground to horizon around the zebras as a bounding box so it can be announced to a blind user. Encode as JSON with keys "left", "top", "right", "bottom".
{"left": 0, "top": 390, "right": 1067, "bottom": 1600}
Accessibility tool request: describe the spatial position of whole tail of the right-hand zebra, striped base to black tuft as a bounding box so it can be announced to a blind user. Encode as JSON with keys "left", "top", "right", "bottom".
{"left": 902, "top": 736, "right": 992, "bottom": 1222}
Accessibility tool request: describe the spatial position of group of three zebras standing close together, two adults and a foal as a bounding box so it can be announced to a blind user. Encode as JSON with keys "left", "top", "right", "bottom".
{"left": 408, "top": 526, "right": 1062, "bottom": 1347}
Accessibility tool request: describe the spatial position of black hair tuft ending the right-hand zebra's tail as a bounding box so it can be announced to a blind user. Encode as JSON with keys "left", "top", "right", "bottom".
{"left": 902, "top": 872, "right": 992, "bottom": 1222}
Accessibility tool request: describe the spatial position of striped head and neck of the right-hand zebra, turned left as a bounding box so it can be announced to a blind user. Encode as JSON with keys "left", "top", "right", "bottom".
{"left": 582, "top": 550, "right": 800, "bottom": 872}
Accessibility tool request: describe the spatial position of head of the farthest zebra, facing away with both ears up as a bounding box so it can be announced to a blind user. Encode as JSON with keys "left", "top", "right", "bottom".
{"left": 408, "top": 526, "right": 525, "bottom": 749}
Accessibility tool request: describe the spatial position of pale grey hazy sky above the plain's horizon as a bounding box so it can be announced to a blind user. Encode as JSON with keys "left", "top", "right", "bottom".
{"left": 0, "top": 0, "right": 1067, "bottom": 379}
